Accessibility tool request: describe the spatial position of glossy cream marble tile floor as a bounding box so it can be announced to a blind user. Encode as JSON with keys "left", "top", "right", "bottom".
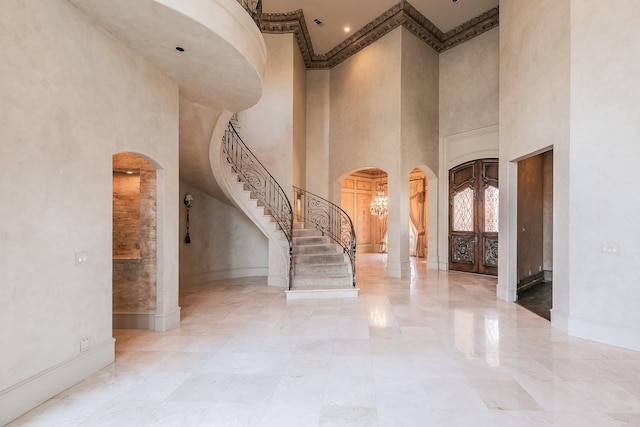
{"left": 9, "top": 254, "right": 640, "bottom": 427}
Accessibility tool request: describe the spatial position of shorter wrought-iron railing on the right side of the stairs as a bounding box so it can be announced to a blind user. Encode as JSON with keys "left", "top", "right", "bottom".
{"left": 293, "top": 186, "right": 356, "bottom": 287}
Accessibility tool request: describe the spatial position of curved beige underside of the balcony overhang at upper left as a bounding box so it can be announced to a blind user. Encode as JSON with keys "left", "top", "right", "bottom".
{"left": 70, "top": 0, "right": 266, "bottom": 111}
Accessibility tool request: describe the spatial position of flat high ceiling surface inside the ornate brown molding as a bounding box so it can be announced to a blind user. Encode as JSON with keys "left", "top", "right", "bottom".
{"left": 262, "top": 0, "right": 498, "bottom": 55}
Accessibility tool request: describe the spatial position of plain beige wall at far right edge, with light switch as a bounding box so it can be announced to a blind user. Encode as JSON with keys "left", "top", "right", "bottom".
{"left": 568, "top": 0, "right": 640, "bottom": 350}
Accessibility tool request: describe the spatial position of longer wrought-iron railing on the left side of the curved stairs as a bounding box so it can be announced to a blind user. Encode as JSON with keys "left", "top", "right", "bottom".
{"left": 222, "top": 122, "right": 293, "bottom": 288}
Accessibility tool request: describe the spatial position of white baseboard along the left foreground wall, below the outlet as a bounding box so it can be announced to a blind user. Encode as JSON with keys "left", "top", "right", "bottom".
{"left": 0, "top": 338, "right": 115, "bottom": 425}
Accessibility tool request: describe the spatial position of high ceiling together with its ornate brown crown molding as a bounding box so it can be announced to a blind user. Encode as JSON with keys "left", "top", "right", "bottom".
{"left": 261, "top": 0, "right": 498, "bottom": 68}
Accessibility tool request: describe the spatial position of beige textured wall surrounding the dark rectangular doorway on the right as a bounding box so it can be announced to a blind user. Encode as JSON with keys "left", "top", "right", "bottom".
{"left": 498, "top": 0, "right": 571, "bottom": 310}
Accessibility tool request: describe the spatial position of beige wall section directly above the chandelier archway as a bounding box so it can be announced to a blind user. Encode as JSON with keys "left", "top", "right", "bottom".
{"left": 329, "top": 29, "right": 400, "bottom": 184}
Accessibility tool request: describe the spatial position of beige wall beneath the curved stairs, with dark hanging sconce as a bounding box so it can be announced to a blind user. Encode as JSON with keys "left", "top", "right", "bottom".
{"left": 180, "top": 182, "right": 268, "bottom": 284}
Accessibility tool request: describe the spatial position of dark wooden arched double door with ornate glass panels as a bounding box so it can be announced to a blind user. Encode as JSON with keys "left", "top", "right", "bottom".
{"left": 449, "top": 159, "right": 499, "bottom": 275}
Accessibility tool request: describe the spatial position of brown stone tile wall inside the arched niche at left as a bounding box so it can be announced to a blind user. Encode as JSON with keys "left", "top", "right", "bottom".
{"left": 113, "top": 153, "right": 157, "bottom": 320}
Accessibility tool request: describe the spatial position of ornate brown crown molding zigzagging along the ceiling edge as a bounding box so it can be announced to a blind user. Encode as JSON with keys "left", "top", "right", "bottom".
{"left": 261, "top": 0, "right": 499, "bottom": 69}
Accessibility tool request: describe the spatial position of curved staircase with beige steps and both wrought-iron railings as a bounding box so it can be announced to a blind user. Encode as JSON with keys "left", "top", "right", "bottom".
{"left": 212, "top": 122, "right": 358, "bottom": 299}
